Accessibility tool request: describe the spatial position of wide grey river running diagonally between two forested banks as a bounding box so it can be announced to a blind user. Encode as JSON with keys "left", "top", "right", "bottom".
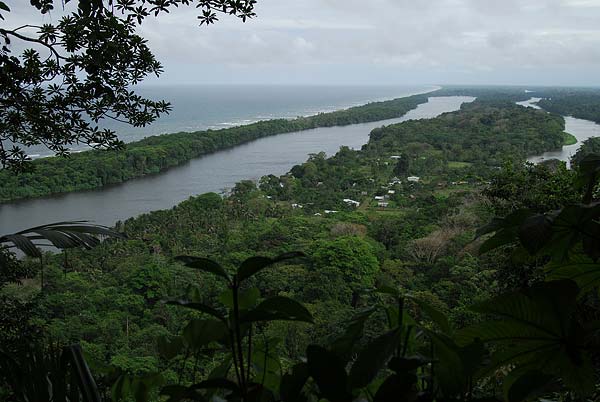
{"left": 0, "top": 97, "right": 474, "bottom": 233}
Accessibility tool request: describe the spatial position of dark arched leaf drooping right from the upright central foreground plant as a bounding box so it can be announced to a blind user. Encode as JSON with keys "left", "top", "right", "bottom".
{"left": 240, "top": 296, "right": 313, "bottom": 323}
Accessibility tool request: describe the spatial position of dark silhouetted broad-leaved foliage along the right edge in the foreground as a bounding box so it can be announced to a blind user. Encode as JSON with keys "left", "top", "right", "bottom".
{"left": 474, "top": 154, "right": 600, "bottom": 395}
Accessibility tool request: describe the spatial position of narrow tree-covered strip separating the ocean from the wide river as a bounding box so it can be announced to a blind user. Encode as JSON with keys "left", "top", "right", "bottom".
{"left": 0, "top": 94, "right": 428, "bottom": 202}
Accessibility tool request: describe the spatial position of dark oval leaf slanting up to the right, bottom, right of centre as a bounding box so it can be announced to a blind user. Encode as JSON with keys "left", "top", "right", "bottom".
{"left": 350, "top": 328, "right": 402, "bottom": 388}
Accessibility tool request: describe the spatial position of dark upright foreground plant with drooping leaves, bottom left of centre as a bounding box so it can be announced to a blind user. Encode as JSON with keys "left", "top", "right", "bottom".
{"left": 161, "top": 253, "right": 313, "bottom": 401}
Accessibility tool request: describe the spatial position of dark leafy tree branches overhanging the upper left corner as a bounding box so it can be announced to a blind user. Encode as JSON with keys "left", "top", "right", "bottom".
{"left": 0, "top": 0, "right": 256, "bottom": 171}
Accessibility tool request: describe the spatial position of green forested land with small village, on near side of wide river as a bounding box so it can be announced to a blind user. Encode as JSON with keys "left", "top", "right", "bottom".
{"left": 0, "top": 95, "right": 599, "bottom": 402}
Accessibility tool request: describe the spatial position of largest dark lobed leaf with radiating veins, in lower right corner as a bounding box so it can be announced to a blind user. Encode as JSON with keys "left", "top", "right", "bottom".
{"left": 456, "top": 281, "right": 594, "bottom": 394}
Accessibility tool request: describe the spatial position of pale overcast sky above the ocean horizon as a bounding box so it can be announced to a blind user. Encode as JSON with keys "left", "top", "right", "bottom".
{"left": 4, "top": 0, "right": 600, "bottom": 86}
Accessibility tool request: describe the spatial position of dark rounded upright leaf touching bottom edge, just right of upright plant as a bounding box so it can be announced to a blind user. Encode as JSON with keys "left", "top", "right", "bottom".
{"left": 306, "top": 345, "right": 352, "bottom": 402}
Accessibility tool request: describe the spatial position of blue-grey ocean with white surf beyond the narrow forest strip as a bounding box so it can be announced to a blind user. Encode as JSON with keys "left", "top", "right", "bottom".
{"left": 27, "top": 85, "right": 438, "bottom": 158}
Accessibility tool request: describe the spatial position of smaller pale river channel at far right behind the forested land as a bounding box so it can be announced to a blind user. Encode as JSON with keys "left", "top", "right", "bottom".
{"left": 518, "top": 98, "right": 600, "bottom": 167}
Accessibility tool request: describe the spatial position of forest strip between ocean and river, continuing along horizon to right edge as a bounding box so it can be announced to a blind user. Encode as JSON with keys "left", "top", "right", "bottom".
{"left": 0, "top": 87, "right": 600, "bottom": 202}
